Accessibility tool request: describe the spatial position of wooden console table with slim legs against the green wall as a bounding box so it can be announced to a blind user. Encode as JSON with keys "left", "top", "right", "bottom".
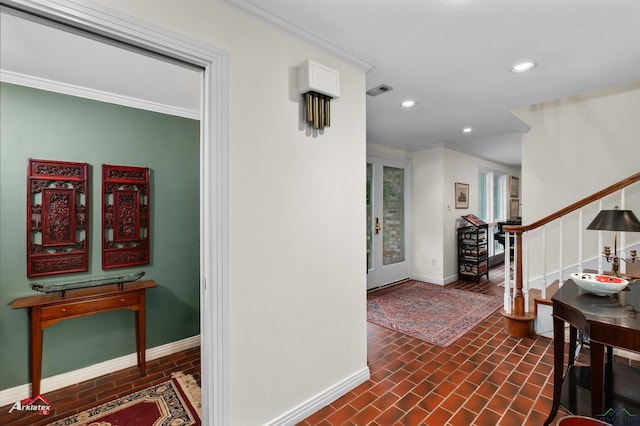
{"left": 11, "top": 280, "right": 156, "bottom": 396}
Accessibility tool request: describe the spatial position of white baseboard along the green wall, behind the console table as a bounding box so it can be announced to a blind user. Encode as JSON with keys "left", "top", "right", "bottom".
{"left": 0, "top": 335, "right": 200, "bottom": 407}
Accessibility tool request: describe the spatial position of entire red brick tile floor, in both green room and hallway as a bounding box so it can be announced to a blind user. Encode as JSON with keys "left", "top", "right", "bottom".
{"left": 0, "top": 268, "right": 640, "bottom": 426}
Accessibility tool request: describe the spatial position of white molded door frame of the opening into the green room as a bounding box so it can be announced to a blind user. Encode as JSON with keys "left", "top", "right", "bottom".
{"left": 0, "top": 0, "right": 230, "bottom": 425}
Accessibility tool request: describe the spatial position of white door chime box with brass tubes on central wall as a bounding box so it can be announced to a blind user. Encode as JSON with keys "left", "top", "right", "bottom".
{"left": 297, "top": 60, "right": 340, "bottom": 129}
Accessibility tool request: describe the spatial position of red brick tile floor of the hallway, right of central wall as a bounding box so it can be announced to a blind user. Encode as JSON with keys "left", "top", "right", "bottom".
{"left": 299, "top": 272, "right": 584, "bottom": 426}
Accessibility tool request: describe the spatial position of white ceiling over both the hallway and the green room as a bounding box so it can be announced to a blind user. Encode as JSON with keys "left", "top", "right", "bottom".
{"left": 0, "top": 0, "right": 640, "bottom": 167}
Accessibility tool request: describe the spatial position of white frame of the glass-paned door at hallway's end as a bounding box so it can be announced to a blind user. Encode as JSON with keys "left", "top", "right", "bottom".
{"left": 367, "top": 152, "right": 413, "bottom": 290}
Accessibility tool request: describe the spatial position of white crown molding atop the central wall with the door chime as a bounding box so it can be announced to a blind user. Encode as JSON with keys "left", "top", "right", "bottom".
{"left": 224, "top": 0, "right": 374, "bottom": 72}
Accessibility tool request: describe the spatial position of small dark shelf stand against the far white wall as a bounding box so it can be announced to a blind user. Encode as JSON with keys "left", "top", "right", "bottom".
{"left": 458, "top": 215, "right": 489, "bottom": 282}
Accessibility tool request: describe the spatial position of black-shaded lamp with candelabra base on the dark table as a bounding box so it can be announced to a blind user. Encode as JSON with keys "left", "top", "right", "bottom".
{"left": 587, "top": 206, "right": 640, "bottom": 277}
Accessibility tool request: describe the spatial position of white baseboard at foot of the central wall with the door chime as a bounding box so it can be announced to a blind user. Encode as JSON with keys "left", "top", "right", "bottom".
{"left": 267, "top": 367, "right": 371, "bottom": 426}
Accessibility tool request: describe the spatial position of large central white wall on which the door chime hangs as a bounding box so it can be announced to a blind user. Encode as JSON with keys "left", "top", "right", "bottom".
{"left": 91, "top": 0, "right": 367, "bottom": 425}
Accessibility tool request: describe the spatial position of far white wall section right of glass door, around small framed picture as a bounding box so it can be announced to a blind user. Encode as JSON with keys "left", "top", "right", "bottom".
{"left": 412, "top": 148, "right": 520, "bottom": 284}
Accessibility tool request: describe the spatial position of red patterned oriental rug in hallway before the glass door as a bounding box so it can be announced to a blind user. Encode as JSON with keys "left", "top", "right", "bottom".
{"left": 367, "top": 280, "right": 502, "bottom": 348}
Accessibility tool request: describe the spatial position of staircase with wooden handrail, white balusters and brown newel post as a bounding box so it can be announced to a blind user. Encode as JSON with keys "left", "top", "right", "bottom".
{"left": 501, "top": 173, "right": 640, "bottom": 337}
